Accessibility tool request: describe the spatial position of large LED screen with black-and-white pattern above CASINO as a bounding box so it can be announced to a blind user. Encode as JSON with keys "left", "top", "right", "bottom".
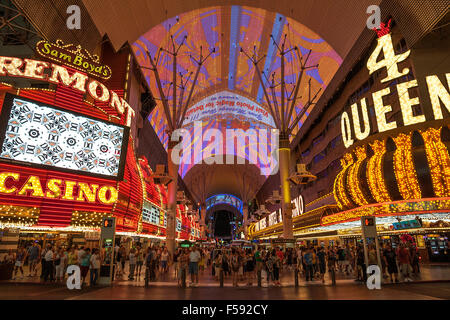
{"left": 0, "top": 94, "right": 129, "bottom": 180}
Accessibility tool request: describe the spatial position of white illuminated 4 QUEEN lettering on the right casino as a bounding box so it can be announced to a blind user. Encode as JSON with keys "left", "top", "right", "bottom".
{"left": 341, "top": 26, "right": 450, "bottom": 148}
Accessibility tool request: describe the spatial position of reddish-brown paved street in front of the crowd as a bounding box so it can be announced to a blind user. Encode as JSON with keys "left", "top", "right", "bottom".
{"left": 0, "top": 265, "right": 450, "bottom": 300}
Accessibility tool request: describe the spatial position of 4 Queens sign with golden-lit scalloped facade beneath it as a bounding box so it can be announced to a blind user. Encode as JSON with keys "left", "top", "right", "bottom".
{"left": 321, "top": 21, "right": 450, "bottom": 225}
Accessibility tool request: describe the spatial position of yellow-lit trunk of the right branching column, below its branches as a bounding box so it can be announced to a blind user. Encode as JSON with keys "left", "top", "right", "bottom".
{"left": 279, "top": 134, "right": 294, "bottom": 239}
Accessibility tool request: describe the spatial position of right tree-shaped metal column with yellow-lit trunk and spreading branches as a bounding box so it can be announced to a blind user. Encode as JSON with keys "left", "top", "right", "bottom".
{"left": 240, "top": 34, "right": 322, "bottom": 239}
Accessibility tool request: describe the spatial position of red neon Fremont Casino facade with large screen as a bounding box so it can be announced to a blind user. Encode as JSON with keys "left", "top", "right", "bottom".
{"left": 0, "top": 43, "right": 200, "bottom": 258}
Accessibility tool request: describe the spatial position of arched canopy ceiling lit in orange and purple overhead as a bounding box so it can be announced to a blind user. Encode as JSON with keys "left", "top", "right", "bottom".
{"left": 132, "top": 6, "right": 342, "bottom": 161}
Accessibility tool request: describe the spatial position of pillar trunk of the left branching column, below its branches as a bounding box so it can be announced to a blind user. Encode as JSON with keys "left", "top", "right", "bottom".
{"left": 166, "top": 140, "right": 179, "bottom": 255}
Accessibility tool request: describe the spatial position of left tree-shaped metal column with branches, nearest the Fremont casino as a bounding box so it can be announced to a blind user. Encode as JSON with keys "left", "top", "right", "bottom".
{"left": 147, "top": 36, "right": 215, "bottom": 253}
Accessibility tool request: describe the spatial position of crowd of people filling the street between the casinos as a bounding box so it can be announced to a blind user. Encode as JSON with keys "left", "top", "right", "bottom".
{"left": 2, "top": 242, "right": 420, "bottom": 287}
